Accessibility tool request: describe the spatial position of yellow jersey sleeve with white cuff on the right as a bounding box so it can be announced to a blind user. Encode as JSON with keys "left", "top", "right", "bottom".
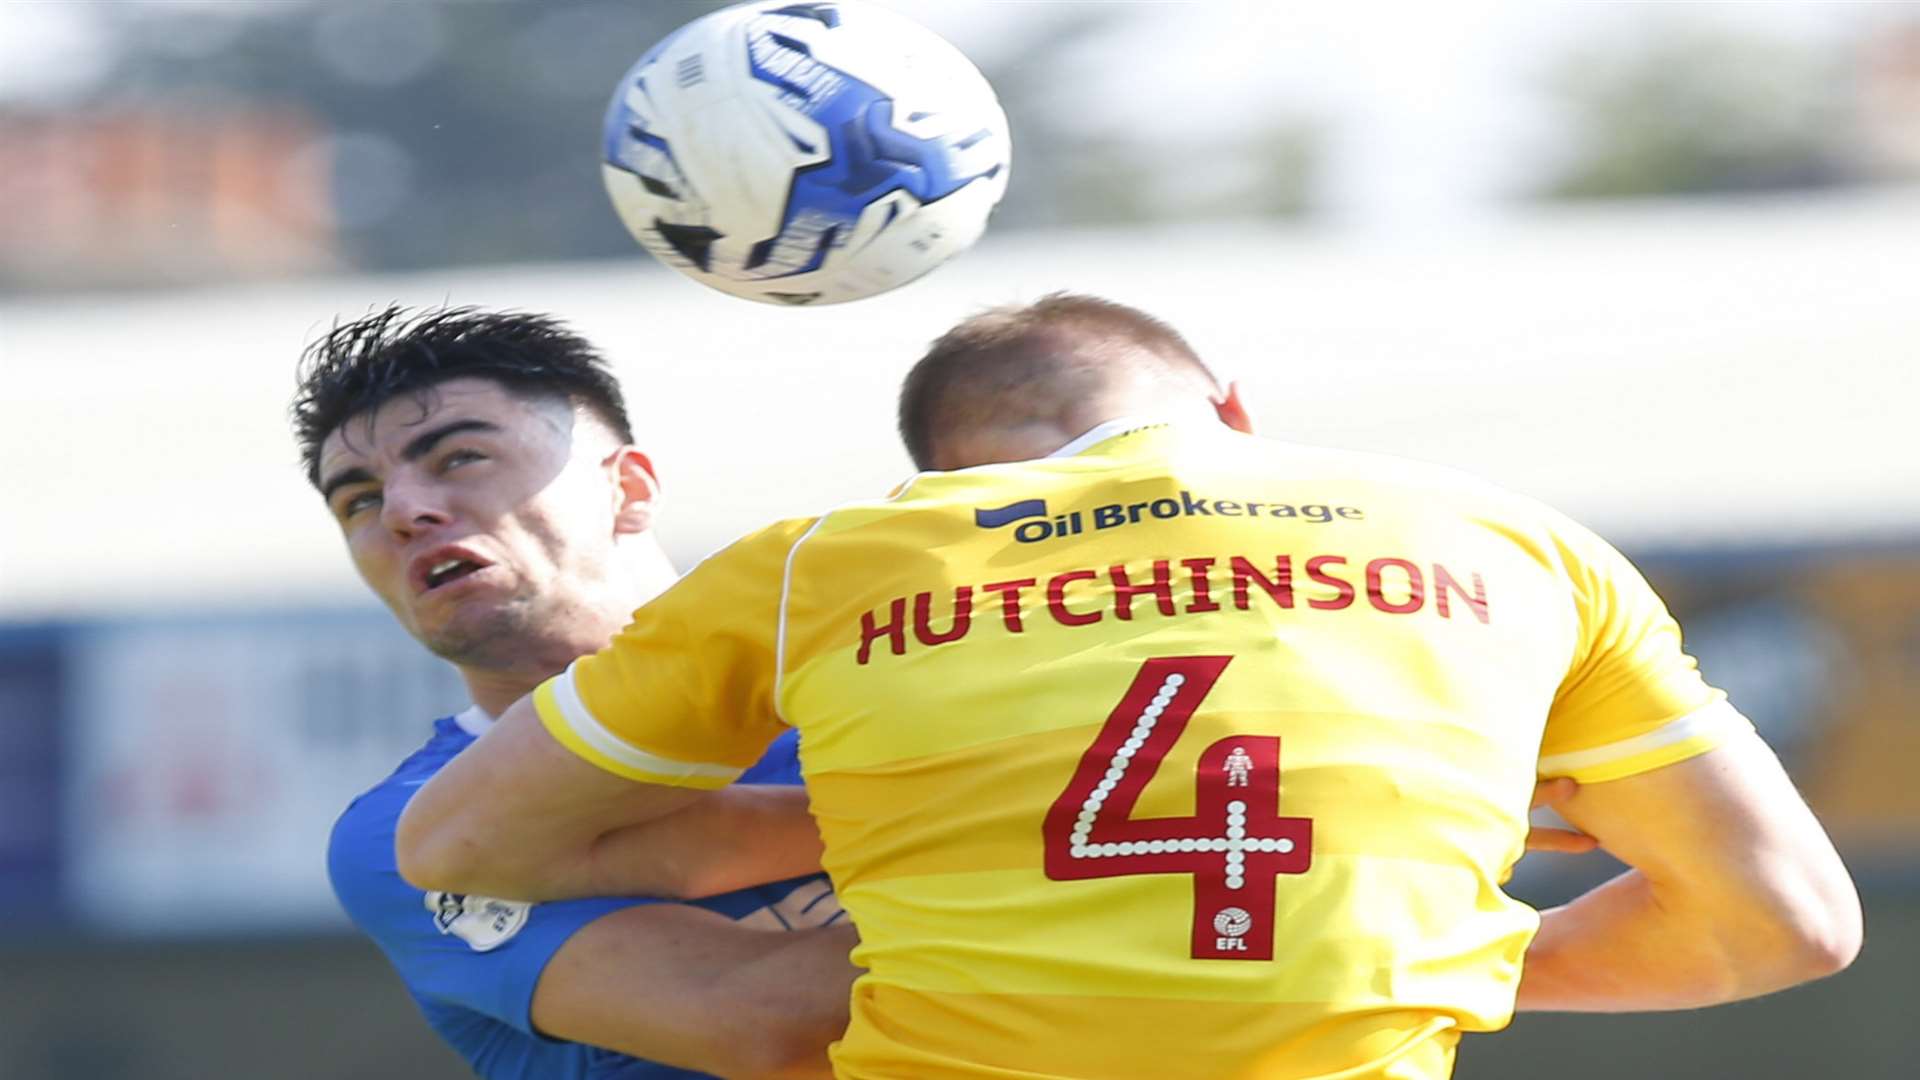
{"left": 1538, "top": 521, "right": 1753, "bottom": 784}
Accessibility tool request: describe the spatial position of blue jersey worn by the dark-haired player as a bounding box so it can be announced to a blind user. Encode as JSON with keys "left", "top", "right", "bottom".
{"left": 326, "top": 709, "right": 841, "bottom": 1080}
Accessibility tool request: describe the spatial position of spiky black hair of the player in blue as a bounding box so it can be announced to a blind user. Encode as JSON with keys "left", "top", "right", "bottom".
{"left": 288, "top": 304, "right": 634, "bottom": 486}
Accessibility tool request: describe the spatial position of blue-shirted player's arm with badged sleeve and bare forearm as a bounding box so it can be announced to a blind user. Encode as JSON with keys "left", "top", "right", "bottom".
{"left": 328, "top": 786, "right": 856, "bottom": 1076}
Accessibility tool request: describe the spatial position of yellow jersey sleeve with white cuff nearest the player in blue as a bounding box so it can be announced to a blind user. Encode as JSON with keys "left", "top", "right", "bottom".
{"left": 534, "top": 521, "right": 812, "bottom": 788}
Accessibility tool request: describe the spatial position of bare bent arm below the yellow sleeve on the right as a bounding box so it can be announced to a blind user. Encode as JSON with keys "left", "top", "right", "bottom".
{"left": 1519, "top": 732, "right": 1860, "bottom": 1013}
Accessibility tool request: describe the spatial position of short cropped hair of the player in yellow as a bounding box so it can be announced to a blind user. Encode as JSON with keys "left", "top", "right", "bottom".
{"left": 900, "top": 292, "right": 1219, "bottom": 469}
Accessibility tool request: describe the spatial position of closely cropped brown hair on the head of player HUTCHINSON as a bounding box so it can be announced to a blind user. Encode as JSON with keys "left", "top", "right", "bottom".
{"left": 900, "top": 292, "right": 1215, "bottom": 469}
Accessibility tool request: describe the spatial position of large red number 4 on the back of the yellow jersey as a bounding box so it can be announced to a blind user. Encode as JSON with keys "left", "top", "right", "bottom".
{"left": 1043, "top": 655, "right": 1313, "bottom": 961}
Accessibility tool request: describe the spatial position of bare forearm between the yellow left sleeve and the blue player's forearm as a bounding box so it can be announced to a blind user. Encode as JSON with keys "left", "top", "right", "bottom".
{"left": 593, "top": 784, "right": 820, "bottom": 899}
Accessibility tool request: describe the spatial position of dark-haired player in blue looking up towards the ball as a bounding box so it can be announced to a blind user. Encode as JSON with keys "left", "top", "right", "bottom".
{"left": 303, "top": 309, "right": 854, "bottom": 1080}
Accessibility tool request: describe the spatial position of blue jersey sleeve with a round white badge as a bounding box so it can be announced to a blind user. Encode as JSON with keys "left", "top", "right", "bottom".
{"left": 326, "top": 788, "right": 659, "bottom": 1036}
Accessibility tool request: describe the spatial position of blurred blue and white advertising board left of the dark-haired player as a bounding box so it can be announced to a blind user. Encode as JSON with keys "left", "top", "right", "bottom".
{"left": 0, "top": 611, "right": 465, "bottom": 940}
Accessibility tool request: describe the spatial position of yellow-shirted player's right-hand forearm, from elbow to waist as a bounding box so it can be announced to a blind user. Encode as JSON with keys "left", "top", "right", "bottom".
{"left": 1515, "top": 871, "right": 1859, "bottom": 1013}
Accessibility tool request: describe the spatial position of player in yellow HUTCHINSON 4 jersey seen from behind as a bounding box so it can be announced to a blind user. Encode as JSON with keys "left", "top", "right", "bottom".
{"left": 399, "top": 296, "right": 1860, "bottom": 1080}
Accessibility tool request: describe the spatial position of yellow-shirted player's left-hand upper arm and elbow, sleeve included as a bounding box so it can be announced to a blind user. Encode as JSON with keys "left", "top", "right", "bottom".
{"left": 397, "top": 523, "right": 820, "bottom": 899}
